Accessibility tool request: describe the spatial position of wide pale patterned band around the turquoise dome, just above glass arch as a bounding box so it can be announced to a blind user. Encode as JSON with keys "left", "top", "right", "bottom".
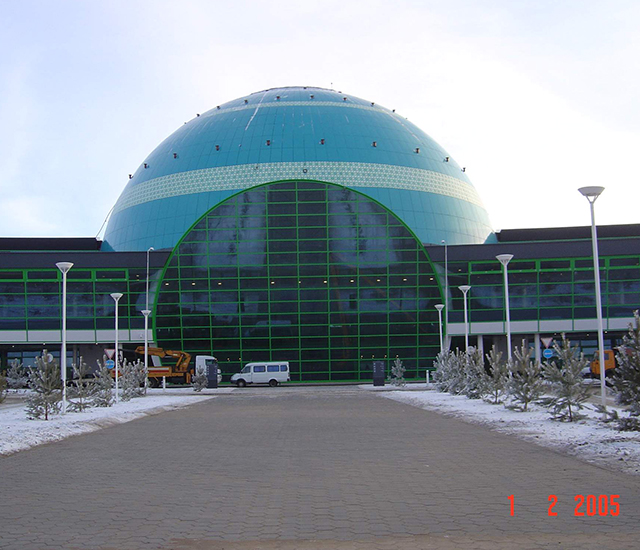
{"left": 113, "top": 162, "right": 483, "bottom": 213}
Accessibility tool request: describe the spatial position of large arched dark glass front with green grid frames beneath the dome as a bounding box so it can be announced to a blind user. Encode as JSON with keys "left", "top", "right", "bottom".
{"left": 154, "top": 181, "right": 440, "bottom": 381}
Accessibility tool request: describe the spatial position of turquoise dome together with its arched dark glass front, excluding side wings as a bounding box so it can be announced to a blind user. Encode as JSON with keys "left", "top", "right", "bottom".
{"left": 103, "top": 87, "right": 491, "bottom": 380}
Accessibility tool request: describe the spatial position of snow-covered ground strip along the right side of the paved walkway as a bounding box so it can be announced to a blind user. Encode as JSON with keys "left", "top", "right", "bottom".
{"left": 378, "top": 384, "right": 640, "bottom": 475}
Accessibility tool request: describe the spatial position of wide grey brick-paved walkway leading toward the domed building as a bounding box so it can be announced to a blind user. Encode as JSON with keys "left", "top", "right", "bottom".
{"left": 0, "top": 387, "right": 640, "bottom": 550}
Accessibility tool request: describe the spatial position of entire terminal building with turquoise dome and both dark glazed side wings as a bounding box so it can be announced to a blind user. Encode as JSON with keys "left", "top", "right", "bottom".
{"left": 0, "top": 87, "right": 640, "bottom": 381}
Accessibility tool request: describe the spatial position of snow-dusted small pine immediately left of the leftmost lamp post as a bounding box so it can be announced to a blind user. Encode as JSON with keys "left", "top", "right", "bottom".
{"left": 27, "top": 350, "right": 62, "bottom": 420}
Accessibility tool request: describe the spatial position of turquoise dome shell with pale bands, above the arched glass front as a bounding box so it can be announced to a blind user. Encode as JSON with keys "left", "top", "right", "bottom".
{"left": 104, "top": 87, "right": 491, "bottom": 250}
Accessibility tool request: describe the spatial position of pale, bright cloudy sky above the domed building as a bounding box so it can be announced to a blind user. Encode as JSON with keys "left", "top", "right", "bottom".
{"left": 0, "top": 0, "right": 640, "bottom": 237}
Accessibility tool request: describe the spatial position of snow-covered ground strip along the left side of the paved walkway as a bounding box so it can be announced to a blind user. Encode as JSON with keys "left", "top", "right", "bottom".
{"left": 0, "top": 388, "right": 228, "bottom": 455}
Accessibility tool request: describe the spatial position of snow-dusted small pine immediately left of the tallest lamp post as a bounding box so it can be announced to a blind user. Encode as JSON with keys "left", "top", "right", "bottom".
{"left": 540, "top": 334, "right": 589, "bottom": 422}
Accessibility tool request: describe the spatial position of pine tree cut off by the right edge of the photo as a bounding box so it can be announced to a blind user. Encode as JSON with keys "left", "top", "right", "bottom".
{"left": 611, "top": 311, "right": 640, "bottom": 431}
